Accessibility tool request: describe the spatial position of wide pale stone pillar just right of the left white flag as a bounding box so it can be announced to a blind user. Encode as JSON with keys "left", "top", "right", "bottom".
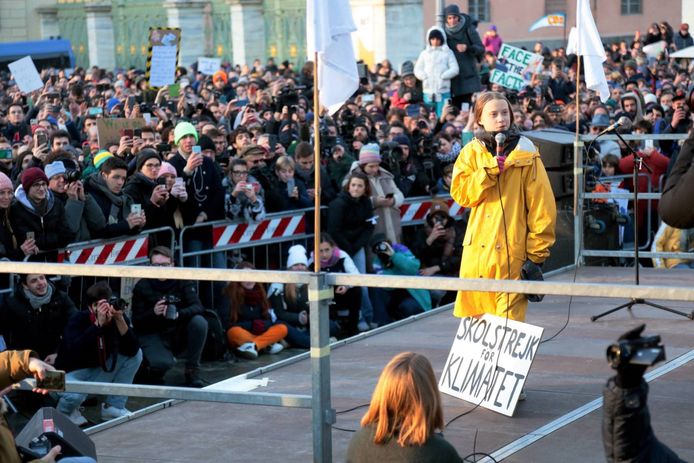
{"left": 350, "top": 0, "right": 425, "bottom": 71}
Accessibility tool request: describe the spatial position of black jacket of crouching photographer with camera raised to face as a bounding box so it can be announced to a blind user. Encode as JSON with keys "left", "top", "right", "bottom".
{"left": 55, "top": 310, "right": 140, "bottom": 371}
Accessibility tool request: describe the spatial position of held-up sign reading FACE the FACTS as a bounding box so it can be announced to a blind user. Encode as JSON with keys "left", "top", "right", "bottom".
{"left": 489, "top": 44, "right": 544, "bottom": 91}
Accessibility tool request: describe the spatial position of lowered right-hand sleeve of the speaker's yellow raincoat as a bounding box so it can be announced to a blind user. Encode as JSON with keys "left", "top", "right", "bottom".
{"left": 525, "top": 155, "right": 557, "bottom": 264}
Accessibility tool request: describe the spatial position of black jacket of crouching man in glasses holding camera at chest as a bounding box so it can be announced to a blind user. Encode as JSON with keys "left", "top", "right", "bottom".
{"left": 132, "top": 278, "right": 205, "bottom": 335}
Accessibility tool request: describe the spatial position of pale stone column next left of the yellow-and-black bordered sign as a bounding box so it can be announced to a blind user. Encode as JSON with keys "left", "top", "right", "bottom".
{"left": 84, "top": 2, "right": 116, "bottom": 70}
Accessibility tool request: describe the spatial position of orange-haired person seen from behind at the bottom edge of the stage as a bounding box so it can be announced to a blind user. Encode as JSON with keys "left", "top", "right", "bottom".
{"left": 347, "top": 352, "right": 463, "bottom": 463}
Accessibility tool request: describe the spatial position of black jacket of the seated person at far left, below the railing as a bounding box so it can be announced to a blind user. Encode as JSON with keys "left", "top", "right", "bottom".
{"left": 0, "top": 282, "right": 77, "bottom": 359}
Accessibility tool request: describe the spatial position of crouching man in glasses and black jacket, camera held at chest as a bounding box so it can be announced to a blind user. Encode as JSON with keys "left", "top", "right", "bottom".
{"left": 132, "top": 246, "right": 207, "bottom": 387}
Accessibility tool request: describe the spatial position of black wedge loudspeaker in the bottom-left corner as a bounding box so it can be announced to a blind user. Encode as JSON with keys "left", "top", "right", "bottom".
{"left": 16, "top": 407, "right": 96, "bottom": 460}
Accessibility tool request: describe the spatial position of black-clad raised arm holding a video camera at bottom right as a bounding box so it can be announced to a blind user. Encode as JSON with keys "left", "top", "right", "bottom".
{"left": 602, "top": 325, "right": 684, "bottom": 463}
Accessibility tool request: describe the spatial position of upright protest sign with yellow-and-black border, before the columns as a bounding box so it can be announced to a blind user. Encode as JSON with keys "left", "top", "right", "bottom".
{"left": 146, "top": 27, "right": 181, "bottom": 87}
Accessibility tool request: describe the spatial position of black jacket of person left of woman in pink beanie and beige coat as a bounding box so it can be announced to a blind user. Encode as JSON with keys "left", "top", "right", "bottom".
{"left": 328, "top": 191, "right": 374, "bottom": 256}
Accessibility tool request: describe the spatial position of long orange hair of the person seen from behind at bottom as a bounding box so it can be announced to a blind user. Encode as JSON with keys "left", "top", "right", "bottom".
{"left": 361, "top": 352, "right": 443, "bottom": 447}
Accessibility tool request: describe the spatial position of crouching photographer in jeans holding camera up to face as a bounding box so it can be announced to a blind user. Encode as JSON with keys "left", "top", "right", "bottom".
{"left": 55, "top": 281, "right": 142, "bottom": 426}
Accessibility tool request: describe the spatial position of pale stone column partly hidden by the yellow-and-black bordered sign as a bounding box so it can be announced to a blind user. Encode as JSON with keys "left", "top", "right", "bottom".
{"left": 164, "top": 0, "right": 206, "bottom": 67}
